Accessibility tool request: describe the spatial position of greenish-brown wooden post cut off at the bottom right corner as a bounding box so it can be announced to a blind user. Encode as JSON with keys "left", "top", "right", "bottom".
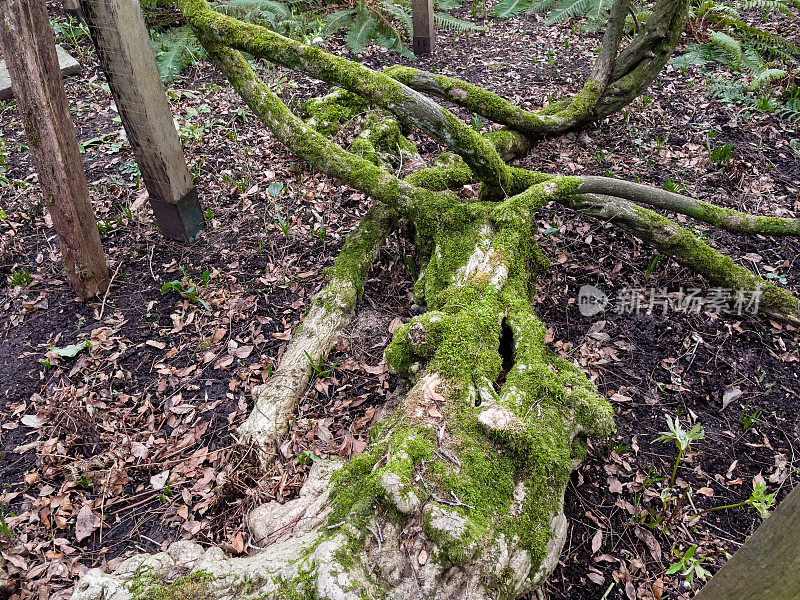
{"left": 694, "top": 485, "right": 800, "bottom": 600}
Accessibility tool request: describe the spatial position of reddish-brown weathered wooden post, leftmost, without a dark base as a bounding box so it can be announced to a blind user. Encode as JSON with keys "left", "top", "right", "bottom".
{"left": 0, "top": 0, "right": 109, "bottom": 300}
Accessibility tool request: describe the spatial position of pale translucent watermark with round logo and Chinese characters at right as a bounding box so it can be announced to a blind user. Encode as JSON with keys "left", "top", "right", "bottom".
{"left": 578, "top": 285, "right": 762, "bottom": 317}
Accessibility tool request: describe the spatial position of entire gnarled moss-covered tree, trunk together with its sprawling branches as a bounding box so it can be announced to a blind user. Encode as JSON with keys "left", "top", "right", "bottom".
{"left": 74, "top": 0, "right": 800, "bottom": 600}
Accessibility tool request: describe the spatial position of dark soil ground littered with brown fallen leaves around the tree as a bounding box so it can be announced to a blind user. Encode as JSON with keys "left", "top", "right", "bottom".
{"left": 0, "top": 5, "right": 800, "bottom": 600}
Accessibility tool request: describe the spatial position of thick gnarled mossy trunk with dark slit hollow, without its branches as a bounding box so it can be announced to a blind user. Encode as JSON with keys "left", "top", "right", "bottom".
{"left": 73, "top": 179, "right": 613, "bottom": 600}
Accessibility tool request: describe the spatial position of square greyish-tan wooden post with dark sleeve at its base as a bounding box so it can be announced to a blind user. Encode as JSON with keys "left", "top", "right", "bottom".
{"left": 80, "top": 0, "right": 204, "bottom": 240}
